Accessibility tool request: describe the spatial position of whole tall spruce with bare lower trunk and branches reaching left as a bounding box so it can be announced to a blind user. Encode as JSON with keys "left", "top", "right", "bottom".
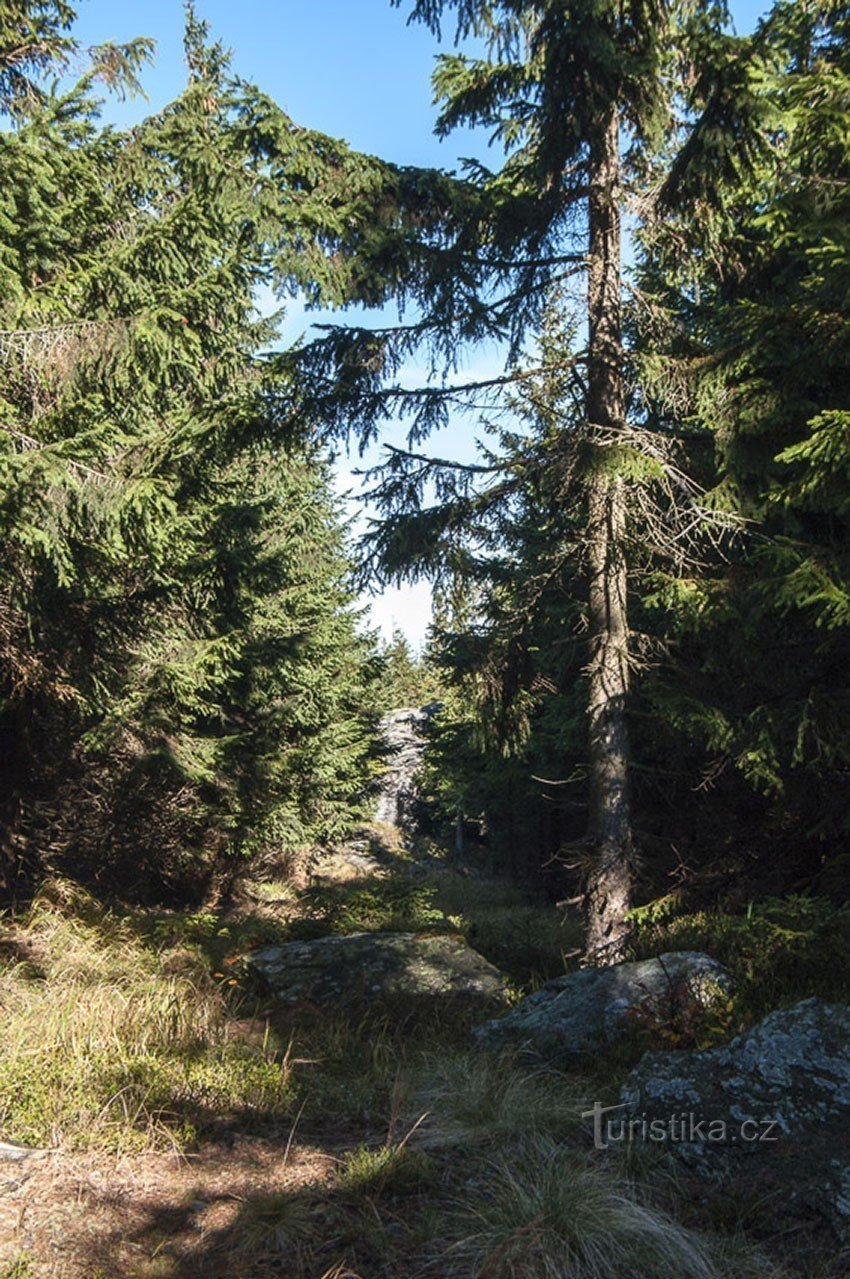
{"left": 323, "top": 0, "right": 763, "bottom": 959}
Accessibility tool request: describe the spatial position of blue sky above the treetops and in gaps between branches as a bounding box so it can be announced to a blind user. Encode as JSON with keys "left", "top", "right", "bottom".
{"left": 75, "top": 0, "right": 768, "bottom": 645}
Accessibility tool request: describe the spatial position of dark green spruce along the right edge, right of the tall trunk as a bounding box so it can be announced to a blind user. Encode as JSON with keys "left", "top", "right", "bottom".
{"left": 640, "top": 3, "right": 850, "bottom": 879}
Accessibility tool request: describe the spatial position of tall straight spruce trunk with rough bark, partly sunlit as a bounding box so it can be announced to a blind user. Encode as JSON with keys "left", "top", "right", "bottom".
{"left": 584, "top": 110, "right": 633, "bottom": 963}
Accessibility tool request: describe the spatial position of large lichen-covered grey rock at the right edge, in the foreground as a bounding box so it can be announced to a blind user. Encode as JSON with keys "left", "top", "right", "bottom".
{"left": 621, "top": 999, "right": 850, "bottom": 1242}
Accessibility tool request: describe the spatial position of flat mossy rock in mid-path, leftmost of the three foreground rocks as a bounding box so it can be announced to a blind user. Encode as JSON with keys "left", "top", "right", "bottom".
{"left": 245, "top": 932, "right": 506, "bottom": 1009}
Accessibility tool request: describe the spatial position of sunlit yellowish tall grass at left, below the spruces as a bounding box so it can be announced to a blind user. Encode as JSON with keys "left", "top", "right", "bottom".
{"left": 0, "top": 885, "right": 294, "bottom": 1151}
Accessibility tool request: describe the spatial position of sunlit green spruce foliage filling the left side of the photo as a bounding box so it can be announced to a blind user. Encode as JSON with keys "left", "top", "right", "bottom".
{"left": 0, "top": 4, "right": 375, "bottom": 893}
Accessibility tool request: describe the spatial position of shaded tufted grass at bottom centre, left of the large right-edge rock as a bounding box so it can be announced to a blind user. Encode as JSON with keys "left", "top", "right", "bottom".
{"left": 224, "top": 1048, "right": 777, "bottom": 1279}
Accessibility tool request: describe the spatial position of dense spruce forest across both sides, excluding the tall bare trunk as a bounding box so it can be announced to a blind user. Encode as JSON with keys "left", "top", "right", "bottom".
{"left": 0, "top": 0, "right": 850, "bottom": 941}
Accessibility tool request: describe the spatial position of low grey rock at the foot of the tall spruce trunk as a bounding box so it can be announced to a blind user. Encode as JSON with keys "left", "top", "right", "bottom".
{"left": 474, "top": 950, "right": 730, "bottom": 1062}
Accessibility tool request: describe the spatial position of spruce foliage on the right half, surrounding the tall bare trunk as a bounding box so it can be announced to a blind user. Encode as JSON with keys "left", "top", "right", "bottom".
{"left": 380, "top": 3, "right": 849, "bottom": 910}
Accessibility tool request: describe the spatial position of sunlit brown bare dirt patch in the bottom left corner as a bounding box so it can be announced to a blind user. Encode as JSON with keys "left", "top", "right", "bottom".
{"left": 0, "top": 1134, "right": 335, "bottom": 1279}
